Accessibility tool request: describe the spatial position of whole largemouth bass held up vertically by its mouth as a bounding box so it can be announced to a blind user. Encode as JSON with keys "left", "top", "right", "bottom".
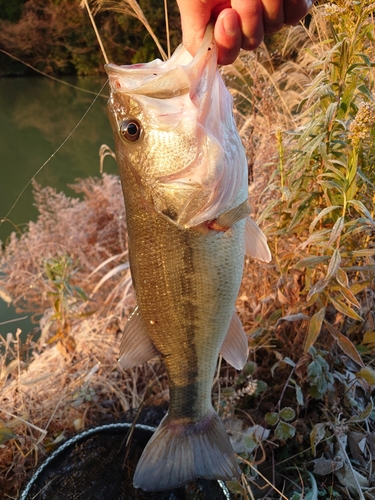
{"left": 105, "top": 25, "right": 271, "bottom": 491}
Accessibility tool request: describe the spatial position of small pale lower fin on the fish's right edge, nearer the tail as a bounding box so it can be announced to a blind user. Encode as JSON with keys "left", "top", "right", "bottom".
{"left": 220, "top": 312, "right": 249, "bottom": 370}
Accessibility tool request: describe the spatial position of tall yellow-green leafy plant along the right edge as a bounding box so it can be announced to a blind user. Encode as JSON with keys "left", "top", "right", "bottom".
{"left": 276, "top": 0, "right": 375, "bottom": 321}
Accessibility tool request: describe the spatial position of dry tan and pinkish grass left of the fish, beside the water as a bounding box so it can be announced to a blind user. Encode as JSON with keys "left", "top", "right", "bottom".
{"left": 0, "top": 174, "right": 173, "bottom": 498}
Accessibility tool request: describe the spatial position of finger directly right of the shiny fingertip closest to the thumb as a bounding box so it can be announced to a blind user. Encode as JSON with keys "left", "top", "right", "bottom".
{"left": 232, "top": 0, "right": 264, "bottom": 50}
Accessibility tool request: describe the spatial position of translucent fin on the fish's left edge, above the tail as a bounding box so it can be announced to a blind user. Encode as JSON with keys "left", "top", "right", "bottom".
{"left": 118, "top": 307, "right": 160, "bottom": 369}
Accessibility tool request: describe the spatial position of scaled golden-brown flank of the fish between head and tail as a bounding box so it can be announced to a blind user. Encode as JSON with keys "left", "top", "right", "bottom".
{"left": 124, "top": 186, "right": 244, "bottom": 419}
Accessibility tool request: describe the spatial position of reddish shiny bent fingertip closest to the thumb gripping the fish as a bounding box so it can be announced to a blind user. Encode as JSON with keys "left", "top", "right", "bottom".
{"left": 215, "top": 9, "right": 242, "bottom": 64}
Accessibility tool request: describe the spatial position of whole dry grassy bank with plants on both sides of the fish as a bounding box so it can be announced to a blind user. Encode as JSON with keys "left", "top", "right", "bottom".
{"left": 0, "top": 0, "right": 375, "bottom": 500}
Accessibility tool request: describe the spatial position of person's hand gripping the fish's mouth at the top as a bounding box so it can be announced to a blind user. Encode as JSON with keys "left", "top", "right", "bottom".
{"left": 177, "top": 0, "right": 312, "bottom": 64}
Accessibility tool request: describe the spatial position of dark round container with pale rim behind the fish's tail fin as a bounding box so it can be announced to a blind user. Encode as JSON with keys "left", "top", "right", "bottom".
{"left": 19, "top": 423, "right": 230, "bottom": 500}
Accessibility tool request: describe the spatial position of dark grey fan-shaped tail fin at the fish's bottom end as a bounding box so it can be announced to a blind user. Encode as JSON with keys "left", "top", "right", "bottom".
{"left": 134, "top": 410, "right": 240, "bottom": 491}
